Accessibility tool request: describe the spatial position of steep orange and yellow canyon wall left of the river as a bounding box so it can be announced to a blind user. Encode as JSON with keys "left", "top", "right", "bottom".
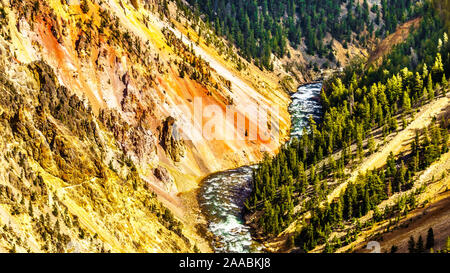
{"left": 0, "top": 0, "right": 289, "bottom": 251}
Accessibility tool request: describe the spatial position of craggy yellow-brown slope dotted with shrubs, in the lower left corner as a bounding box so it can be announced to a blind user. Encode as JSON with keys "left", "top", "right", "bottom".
{"left": 0, "top": 54, "right": 193, "bottom": 252}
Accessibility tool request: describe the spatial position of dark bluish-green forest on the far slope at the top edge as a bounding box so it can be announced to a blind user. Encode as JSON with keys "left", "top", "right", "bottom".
{"left": 182, "top": 0, "right": 416, "bottom": 69}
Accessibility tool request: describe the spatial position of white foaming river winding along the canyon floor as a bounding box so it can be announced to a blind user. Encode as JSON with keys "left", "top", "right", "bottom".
{"left": 199, "top": 83, "right": 322, "bottom": 253}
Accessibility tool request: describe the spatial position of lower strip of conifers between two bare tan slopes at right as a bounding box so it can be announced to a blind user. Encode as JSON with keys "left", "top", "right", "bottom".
{"left": 295, "top": 120, "right": 450, "bottom": 251}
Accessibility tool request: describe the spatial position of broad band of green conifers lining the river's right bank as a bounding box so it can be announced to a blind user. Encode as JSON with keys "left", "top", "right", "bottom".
{"left": 246, "top": 1, "right": 450, "bottom": 244}
